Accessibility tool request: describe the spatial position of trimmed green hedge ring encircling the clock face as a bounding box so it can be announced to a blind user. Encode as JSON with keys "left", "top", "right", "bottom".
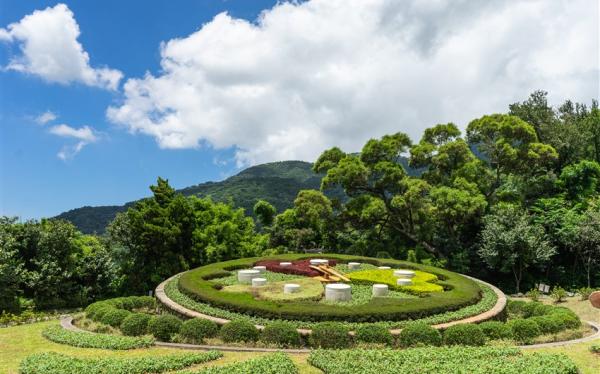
{"left": 178, "top": 254, "right": 482, "bottom": 322}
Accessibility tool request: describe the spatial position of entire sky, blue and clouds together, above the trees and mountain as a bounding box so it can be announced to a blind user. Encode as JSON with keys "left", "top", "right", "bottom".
{"left": 0, "top": 0, "right": 600, "bottom": 218}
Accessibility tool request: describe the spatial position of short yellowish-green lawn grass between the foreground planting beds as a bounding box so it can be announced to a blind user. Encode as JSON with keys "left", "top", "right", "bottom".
{"left": 0, "top": 297, "right": 600, "bottom": 374}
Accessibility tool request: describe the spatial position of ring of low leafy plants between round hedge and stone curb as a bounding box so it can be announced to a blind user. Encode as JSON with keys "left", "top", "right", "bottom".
{"left": 165, "top": 274, "right": 497, "bottom": 329}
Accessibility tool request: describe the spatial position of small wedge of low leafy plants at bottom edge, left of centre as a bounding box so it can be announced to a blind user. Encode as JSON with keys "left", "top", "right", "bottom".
{"left": 193, "top": 353, "right": 298, "bottom": 374}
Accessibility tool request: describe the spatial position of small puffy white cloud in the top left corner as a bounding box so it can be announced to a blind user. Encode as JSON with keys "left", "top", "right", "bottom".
{"left": 0, "top": 4, "right": 123, "bottom": 90}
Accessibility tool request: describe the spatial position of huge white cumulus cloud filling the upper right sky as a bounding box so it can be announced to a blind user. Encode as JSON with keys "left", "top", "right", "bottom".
{"left": 107, "top": 0, "right": 599, "bottom": 165}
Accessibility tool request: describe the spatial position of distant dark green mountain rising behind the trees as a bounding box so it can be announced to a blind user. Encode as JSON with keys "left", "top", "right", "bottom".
{"left": 54, "top": 161, "right": 321, "bottom": 234}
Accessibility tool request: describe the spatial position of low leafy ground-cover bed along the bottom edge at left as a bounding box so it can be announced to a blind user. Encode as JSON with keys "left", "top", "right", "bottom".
{"left": 19, "top": 351, "right": 223, "bottom": 374}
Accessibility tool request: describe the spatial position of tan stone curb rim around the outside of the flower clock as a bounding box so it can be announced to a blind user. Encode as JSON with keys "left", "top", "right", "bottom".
{"left": 155, "top": 273, "right": 507, "bottom": 336}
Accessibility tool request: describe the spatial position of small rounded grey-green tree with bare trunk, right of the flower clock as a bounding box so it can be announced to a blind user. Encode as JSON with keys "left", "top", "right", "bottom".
{"left": 479, "top": 204, "right": 556, "bottom": 293}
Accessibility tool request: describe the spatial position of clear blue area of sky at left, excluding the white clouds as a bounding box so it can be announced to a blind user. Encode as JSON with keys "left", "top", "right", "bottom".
{"left": 0, "top": 0, "right": 273, "bottom": 218}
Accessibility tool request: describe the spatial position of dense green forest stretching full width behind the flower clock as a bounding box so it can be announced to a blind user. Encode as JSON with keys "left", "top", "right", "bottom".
{"left": 0, "top": 91, "right": 600, "bottom": 311}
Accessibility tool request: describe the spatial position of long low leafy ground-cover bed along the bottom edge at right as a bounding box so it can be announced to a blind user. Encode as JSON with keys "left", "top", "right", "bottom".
{"left": 308, "top": 346, "right": 578, "bottom": 374}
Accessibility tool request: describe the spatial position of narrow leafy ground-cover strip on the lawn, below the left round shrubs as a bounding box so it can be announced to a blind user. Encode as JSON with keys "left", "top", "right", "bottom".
{"left": 42, "top": 325, "right": 154, "bottom": 349}
